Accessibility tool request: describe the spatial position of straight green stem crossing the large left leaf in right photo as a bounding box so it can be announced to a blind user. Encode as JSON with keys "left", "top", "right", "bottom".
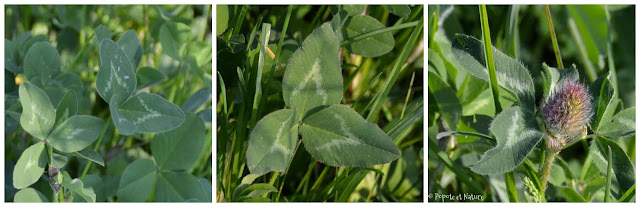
{"left": 479, "top": 4, "right": 502, "bottom": 114}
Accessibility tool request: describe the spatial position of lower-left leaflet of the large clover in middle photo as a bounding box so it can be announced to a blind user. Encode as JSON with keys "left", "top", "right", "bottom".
{"left": 247, "top": 109, "right": 298, "bottom": 175}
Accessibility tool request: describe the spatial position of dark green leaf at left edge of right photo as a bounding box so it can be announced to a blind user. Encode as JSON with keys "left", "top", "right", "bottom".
{"left": 429, "top": 72, "right": 462, "bottom": 130}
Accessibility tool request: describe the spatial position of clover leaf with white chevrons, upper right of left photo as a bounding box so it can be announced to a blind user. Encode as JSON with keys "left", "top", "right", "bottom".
{"left": 96, "top": 35, "right": 185, "bottom": 135}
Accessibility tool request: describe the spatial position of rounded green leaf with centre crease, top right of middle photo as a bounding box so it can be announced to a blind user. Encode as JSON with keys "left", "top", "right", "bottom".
{"left": 342, "top": 15, "right": 396, "bottom": 57}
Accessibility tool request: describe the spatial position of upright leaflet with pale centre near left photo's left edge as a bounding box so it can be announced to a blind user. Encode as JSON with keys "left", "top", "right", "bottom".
{"left": 19, "top": 82, "right": 56, "bottom": 140}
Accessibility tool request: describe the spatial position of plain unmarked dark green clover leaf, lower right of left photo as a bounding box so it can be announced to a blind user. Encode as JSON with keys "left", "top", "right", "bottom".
{"left": 117, "top": 113, "right": 211, "bottom": 202}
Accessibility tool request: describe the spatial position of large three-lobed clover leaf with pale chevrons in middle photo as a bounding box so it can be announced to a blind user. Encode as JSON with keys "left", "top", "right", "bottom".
{"left": 247, "top": 21, "right": 400, "bottom": 175}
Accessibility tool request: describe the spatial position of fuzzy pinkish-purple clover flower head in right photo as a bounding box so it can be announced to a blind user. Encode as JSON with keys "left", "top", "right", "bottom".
{"left": 542, "top": 79, "right": 593, "bottom": 152}
